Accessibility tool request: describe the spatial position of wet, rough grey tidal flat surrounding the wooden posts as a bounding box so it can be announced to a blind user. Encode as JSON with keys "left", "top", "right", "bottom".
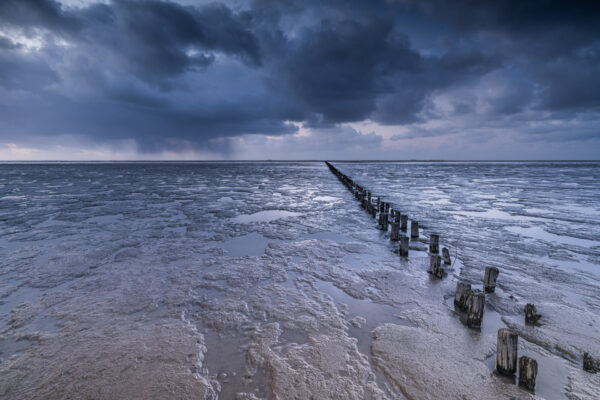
{"left": 0, "top": 163, "right": 600, "bottom": 399}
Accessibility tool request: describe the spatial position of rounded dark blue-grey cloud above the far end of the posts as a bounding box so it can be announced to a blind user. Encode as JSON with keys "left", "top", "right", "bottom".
{"left": 277, "top": 18, "right": 420, "bottom": 122}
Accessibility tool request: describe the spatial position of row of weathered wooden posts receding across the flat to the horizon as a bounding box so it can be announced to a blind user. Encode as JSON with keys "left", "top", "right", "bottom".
{"left": 325, "top": 161, "right": 540, "bottom": 390}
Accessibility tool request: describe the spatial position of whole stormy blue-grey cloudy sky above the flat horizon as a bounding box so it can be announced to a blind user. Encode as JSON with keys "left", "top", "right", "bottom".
{"left": 0, "top": 0, "right": 600, "bottom": 160}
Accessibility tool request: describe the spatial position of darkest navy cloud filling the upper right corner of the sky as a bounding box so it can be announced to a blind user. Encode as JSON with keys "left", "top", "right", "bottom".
{"left": 415, "top": 0, "right": 600, "bottom": 110}
